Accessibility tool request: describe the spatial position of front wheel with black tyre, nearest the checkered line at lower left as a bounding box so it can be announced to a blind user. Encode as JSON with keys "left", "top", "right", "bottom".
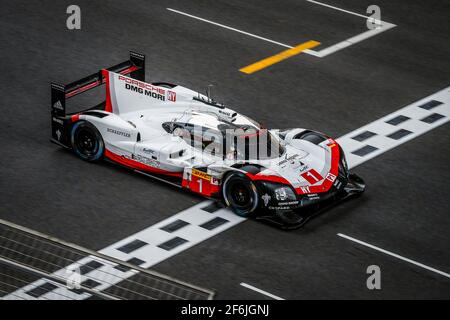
{"left": 222, "top": 172, "right": 259, "bottom": 217}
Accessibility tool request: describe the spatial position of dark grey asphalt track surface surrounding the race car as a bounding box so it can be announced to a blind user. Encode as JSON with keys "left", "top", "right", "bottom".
{"left": 0, "top": 0, "right": 450, "bottom": 299}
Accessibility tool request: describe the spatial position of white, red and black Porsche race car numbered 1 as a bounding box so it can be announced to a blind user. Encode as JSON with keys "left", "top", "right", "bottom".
{"left": 51, "top": 52, "right": 365, "bottom": 229}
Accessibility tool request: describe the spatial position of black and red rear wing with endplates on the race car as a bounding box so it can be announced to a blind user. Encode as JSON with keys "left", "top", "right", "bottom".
{"left": 51, "top": 51, "right": 145, "bottom": 147}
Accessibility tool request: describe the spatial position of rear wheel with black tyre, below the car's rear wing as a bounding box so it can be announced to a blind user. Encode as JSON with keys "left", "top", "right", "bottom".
{"left": 70, "top": 121, "right": 105, "bottom": 162}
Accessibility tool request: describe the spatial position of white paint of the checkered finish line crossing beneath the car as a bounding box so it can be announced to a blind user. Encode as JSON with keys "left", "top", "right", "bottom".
{"left": 4, "top": 87, "right": 450, "bottom": 299}
